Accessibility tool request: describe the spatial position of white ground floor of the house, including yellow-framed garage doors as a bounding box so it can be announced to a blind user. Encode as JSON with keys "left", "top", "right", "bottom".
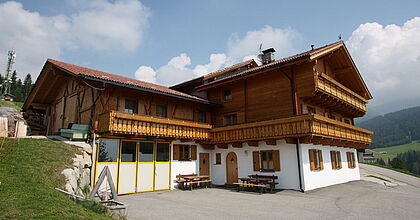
{"left": 92, "top": 136, "right": 360, "bottom": 194}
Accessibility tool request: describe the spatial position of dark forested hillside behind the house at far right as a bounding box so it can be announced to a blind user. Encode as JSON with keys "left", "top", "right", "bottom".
{"left": 357, "top": 106, "right": 420, "bottom": 148}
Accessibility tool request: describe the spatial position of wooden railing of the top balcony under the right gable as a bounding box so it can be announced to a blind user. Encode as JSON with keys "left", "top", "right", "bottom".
{"left": 316, "top": 74, "right": 367, "bottom": 112}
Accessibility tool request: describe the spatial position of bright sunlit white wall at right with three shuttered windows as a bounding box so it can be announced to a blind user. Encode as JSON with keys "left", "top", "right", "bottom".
{"left": 300, "top": 144, "right": 360, "bottom": 191}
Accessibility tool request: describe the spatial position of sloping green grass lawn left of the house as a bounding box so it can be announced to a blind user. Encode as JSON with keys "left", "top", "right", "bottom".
{"left": 0, "top": 138, "right": 112, "bottom": 219}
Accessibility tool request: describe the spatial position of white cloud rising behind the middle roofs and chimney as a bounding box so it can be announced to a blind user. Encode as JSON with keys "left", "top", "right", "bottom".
{"left": 135, "top": 26, "right": 298, "bottom": 86}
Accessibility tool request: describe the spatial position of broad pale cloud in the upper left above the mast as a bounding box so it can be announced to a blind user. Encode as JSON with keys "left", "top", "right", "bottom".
{"left": 0, "top": 0, "right": 151, "bottom": 77}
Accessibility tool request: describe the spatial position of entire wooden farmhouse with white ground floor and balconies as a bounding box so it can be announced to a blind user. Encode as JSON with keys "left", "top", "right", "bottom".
{"left": 23, "top": 41, "right": 372, "bottom": 194}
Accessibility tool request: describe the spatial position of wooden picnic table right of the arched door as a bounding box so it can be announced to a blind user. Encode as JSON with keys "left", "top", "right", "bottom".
{"left": 234, "top": 174, "right": 278, "bottom": 193}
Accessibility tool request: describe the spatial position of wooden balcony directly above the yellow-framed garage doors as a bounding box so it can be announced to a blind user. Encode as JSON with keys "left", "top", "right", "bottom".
{"left": 98, "top": 111, "right": 212, "bottom": 140}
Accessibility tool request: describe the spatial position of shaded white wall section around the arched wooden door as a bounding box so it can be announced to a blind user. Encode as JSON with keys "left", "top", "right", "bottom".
{"left": 209, "top": 140, "right": 299, "bottom": 190}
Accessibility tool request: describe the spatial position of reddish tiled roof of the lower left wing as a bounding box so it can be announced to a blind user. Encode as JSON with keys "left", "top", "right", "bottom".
{"left": 25, "top": 59, "right": 210, "bottom": 110}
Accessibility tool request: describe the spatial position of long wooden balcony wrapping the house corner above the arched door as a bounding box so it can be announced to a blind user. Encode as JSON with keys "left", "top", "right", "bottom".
{"left": 210, "top": 114, "right": 373, "bottom": 148}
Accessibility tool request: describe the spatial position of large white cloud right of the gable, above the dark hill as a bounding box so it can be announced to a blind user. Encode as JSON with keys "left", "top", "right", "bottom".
{"left": 346, "top": 17, "right": 420, "bottom": 108}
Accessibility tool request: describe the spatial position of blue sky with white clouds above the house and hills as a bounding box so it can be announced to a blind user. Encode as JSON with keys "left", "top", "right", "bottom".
{"left": 0, "top": 0, "right": 420, "bottom": 116}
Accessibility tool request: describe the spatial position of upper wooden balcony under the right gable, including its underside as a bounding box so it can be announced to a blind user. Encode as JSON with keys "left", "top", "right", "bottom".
{"left": 307, "top": 74, "right": 368, "bottom": 117}
